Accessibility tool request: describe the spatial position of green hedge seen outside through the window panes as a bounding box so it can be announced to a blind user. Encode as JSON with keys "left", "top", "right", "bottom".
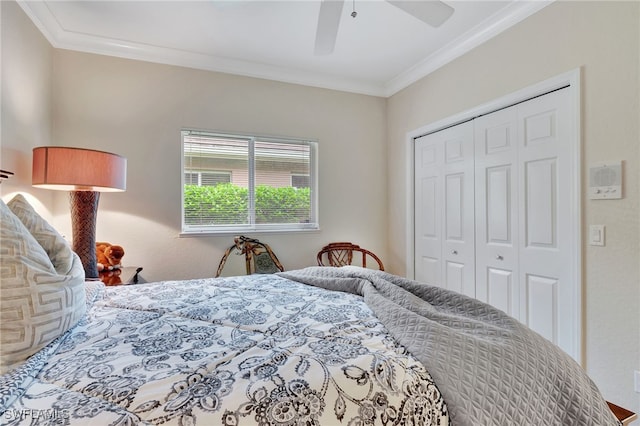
{"left": 184, "top": 183, "right": 311, "bottom": 226}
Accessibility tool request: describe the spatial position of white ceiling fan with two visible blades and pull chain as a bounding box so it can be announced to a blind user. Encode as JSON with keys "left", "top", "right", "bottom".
{"left": 314, "top": 0, "right": 453, "bottom": 55}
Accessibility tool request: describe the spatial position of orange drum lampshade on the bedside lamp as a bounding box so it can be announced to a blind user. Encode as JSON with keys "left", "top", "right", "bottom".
{"left": 31, "top": 146, "right": 127, "bottom": 192}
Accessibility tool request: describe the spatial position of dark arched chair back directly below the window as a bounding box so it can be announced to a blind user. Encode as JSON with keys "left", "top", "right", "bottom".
{"left": 216, "top": 235, "right": 284, "bottom": 277}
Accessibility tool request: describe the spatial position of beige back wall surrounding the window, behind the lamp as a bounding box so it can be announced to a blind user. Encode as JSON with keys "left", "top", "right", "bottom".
{"left": 46, "top": 50, "right": 387, "bottom": 280}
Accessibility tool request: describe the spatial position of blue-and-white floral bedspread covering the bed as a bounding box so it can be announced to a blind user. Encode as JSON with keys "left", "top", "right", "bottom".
{"left": 0, "top": 275, "right": 449, "bottom": 426}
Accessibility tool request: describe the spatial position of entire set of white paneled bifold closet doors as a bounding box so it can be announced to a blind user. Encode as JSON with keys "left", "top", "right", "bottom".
{"left": 414, "top": 88, "right": 580, "bottom": 360}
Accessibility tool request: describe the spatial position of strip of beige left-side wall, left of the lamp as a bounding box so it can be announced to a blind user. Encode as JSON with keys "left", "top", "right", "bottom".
{"left": 0, "top": 1, "right": 53, "bottom": 219}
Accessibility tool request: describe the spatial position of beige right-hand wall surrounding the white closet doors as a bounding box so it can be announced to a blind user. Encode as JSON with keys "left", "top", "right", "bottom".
{"left": 387, "top": 2, "right": 640, "bottom": 412}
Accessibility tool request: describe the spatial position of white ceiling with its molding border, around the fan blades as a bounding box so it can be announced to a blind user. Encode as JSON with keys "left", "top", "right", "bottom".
{"left": 18, "top": 0, "right": 550, "bottom": 97}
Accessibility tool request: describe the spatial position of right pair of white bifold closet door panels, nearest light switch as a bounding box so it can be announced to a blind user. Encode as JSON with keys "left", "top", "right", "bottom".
{"left": 474, "top": 89, "right": 579, "bottom": 353}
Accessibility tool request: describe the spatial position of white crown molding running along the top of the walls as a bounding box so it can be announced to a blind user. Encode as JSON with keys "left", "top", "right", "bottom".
{"left": 17, "top": 0, "right": 553, "bottom": 97}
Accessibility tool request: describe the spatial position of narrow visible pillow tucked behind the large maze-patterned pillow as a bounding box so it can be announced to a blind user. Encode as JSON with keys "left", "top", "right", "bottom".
{"left": 7, "top": 194, "right": 74, "bottom": 275}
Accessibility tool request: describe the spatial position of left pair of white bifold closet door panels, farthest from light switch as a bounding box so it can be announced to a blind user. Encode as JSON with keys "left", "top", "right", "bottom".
{"left": 414, "top": 122, "right": 475, "bottom": 297}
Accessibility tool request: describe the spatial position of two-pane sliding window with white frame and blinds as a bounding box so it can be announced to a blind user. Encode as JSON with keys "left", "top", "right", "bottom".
{"left": 182, "top": 130, "right": 318, "bottom": 234}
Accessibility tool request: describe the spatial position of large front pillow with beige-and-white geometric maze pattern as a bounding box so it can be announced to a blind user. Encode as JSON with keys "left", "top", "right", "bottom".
{"left": 0, "top": 200, "right": 86, "bottom": 374}
